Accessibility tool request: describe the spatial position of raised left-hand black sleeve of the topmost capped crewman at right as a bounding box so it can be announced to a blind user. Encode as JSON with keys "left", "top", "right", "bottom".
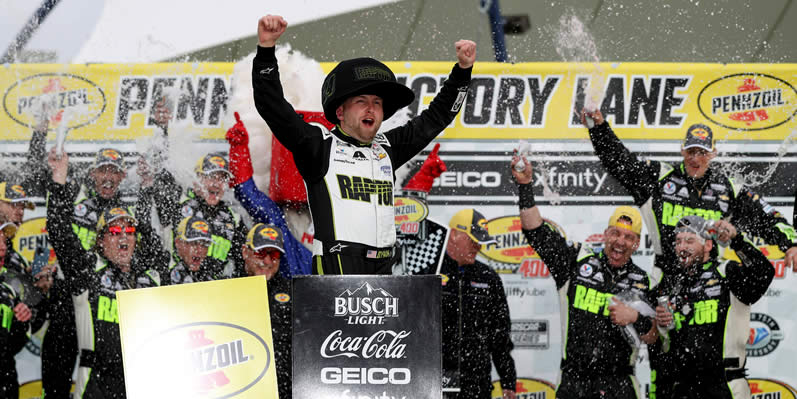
{"left": 589, "top": 122, "right": 662, "bottom": 205}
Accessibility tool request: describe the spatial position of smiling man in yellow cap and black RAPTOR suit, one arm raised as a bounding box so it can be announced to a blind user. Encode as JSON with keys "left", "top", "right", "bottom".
{"left": 511, "top": 156, "right": 655, "bottom": 399}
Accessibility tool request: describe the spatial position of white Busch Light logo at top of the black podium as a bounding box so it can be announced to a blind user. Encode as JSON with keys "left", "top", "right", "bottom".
{"left": 335, "top": 282, "right": 398, "bottom": 325}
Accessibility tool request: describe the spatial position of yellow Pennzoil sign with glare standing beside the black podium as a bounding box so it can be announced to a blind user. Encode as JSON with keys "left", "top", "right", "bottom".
{"left": 117, "top": 276, "right": 277, "bottom": 399}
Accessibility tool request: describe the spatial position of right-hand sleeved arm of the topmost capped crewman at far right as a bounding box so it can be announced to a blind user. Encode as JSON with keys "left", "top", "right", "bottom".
{"left": 731, "top": 188, "right": 797, "bottom": 252}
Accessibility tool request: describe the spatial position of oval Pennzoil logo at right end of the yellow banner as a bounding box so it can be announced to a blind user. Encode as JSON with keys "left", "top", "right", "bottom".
{"left": 697, "top": 73, "right": 797, "bottom": 131}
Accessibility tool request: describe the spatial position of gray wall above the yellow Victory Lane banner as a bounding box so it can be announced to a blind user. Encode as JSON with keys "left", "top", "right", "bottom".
{"left": 169, "top": 0, "right": 797, "bottom": 63}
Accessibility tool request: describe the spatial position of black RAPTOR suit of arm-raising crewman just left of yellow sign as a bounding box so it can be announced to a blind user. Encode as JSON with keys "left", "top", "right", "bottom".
{"left": 47, "top": 183, "right": 165, "bottom": 399}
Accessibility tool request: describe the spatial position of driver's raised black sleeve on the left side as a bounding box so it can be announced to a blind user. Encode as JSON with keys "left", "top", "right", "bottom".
{"left": 252, "top": 46, "right": 326, "bottom": 180}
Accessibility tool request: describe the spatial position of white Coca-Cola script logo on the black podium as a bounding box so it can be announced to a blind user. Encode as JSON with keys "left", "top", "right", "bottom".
{"left": 321, "top": 330, "right": 410, "bottom": 359}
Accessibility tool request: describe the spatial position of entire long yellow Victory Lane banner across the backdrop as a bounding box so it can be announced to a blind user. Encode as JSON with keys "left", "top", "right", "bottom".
{"left": 0, "top": 62, "right": 797, "bottom": 141}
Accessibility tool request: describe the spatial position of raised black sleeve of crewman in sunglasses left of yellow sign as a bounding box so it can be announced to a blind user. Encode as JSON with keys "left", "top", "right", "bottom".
{"left": 47, "top": 181, "right": 99, "bottom": 293}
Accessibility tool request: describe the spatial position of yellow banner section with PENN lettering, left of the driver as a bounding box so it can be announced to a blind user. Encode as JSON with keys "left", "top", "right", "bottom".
{"left": 0, "top": 63, "right": 233, "bottom": 141}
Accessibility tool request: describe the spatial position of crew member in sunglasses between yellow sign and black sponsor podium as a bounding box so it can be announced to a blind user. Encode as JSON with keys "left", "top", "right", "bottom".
{"left": 241, "top": 223, "right": 293, "bottom": 399}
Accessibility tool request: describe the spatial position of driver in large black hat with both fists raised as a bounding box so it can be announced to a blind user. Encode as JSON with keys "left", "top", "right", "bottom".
{"left": 252, "top": 15, "right": 476, "bottom": 274}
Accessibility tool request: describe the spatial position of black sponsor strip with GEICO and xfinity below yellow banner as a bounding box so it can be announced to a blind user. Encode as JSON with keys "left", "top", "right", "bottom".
{"left": 410, "top": 152, "right": 797, "bottom": 206}
